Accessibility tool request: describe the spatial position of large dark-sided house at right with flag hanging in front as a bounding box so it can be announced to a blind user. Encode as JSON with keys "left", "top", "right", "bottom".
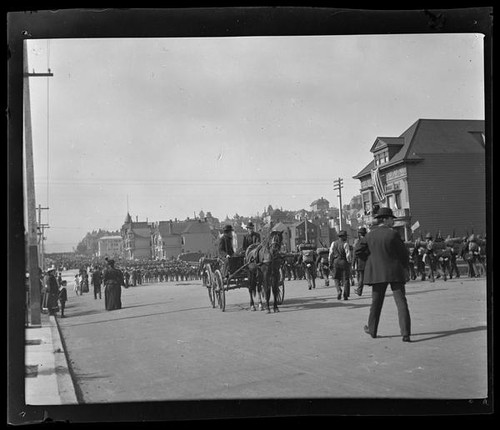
{"left": 354, "top": 119, "right": 486, "bottom": 240}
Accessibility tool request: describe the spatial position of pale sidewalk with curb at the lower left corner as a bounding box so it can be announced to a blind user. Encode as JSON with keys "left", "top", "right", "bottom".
{"left": 24, "top": 313, "right": 78, "bottom": 405}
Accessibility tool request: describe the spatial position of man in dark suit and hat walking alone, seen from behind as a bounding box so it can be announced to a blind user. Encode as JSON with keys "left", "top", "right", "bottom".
{"left": 356, "top": 207, "right": 411, "bottom": 342}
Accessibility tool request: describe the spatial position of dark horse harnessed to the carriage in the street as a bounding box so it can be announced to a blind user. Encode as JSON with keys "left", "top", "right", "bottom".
{"left": 245, "top": 231, "right": 283, "bottom": 313}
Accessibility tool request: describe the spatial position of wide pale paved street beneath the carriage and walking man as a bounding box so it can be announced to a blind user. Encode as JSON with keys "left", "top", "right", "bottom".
{"left": 54, "top": 270, "right": 487, "bottom": 403}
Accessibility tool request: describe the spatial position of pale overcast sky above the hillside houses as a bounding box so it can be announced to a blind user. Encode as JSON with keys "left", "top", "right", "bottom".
{"left": 28, "top": 34, "right": 484, "bottom": 252}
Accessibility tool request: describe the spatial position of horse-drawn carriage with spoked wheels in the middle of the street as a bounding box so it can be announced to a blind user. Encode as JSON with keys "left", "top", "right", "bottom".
{"left": 202, "top": 254, "right": 285, "bottom": 312}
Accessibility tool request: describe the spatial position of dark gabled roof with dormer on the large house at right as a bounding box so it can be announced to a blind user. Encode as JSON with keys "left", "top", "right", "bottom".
{"left": 353, "top": 119, "right": 485, "bottom": 179}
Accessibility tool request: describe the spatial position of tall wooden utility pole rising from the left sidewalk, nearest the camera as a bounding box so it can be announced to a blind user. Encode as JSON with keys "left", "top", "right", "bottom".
{"left": 23, "top": 40, "right": 53, "bottom": 326}
